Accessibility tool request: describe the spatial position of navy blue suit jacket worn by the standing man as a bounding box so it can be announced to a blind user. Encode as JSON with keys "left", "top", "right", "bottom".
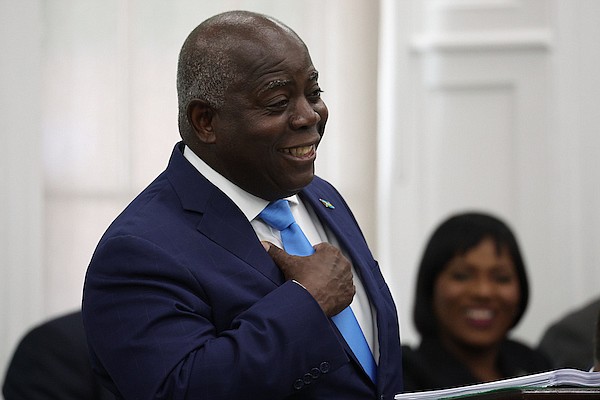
{"left": 83, "top": 143, "right": 402, "bottom": 400}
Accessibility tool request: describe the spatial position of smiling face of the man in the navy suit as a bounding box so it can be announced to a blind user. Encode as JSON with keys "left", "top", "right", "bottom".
{"left": 207, "top": 25, "right": 328, "bottom": 200}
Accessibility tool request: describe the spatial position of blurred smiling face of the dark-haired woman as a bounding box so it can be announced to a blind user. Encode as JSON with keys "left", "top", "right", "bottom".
{"left": 433, "top": 238, "right": 521, "bottom": 350}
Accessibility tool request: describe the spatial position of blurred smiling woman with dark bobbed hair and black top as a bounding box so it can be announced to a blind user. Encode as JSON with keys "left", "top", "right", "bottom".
{"left": 403, "top": 213, "right": 551, "bottom": 391}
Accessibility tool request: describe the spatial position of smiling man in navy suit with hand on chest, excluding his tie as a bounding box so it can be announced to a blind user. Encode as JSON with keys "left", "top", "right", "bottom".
{"left": 83, "top": 11, "right": 402, "bottom": 400}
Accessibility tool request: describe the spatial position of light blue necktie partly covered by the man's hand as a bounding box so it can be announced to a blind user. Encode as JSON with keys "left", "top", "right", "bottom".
{"left": 259, "top": 200, "right": 377, "bottom": 382}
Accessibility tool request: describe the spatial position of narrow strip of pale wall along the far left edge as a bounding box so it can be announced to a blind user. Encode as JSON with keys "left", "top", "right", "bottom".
{"left": 0, "top": 1, "right": 44, "bottom": 388}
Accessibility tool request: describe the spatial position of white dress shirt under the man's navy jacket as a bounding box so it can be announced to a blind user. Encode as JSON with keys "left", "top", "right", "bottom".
{"left": 183, "top": 146, "right": 379, "bottom": 362}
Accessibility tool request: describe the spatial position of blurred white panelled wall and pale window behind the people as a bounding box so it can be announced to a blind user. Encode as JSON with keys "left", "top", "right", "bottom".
{"left": 0, "top": 0, "right": 600, "bottom": 388}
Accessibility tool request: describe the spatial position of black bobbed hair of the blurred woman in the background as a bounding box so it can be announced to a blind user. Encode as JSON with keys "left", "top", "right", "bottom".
{"left": 413, "top": 212, "right": 529, "bottom": 338}
